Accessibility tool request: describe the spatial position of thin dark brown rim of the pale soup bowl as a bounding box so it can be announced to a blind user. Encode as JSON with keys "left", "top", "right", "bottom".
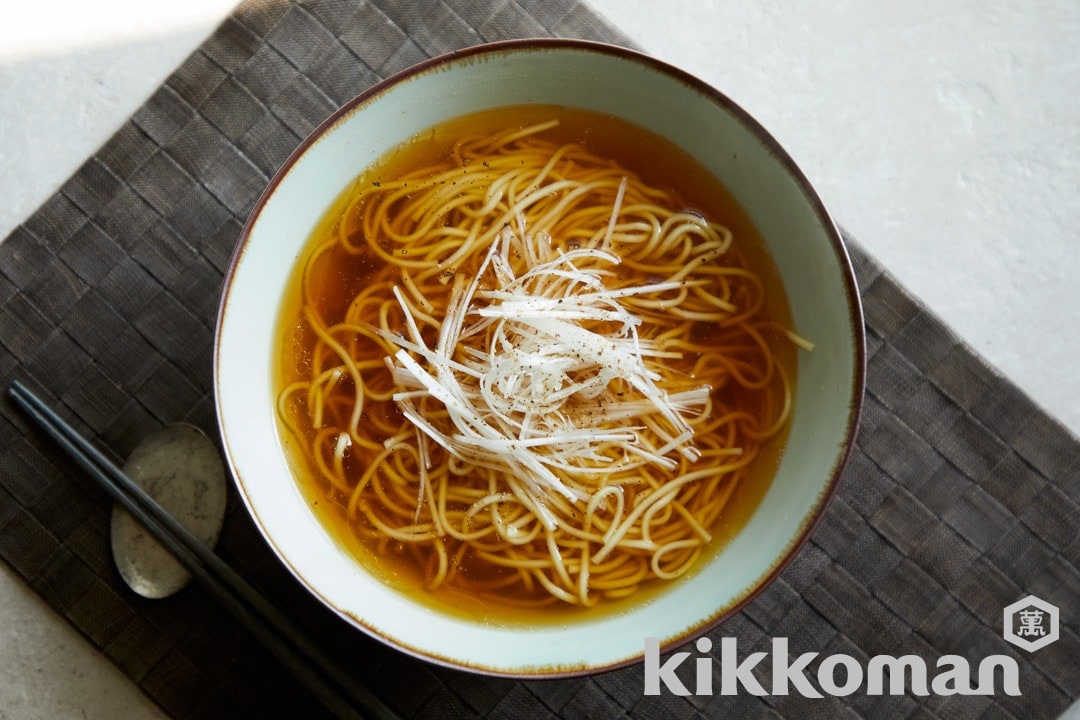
{"left": 213, "top": 38, "right": 866, "bottom": 680}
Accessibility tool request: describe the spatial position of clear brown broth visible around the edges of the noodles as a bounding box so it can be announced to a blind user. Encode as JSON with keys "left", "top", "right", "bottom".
{"left": 275, "top": 105, "right": 796, "bottom": 624}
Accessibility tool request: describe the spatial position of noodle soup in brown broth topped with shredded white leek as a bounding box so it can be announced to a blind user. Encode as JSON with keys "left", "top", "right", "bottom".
{"left": 276, "top": 106, "right": 810, "bottom": 622}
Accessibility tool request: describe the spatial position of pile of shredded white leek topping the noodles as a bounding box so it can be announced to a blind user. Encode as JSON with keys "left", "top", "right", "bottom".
{"left": 379, "top": 211, "right": 710, "bottom": 520}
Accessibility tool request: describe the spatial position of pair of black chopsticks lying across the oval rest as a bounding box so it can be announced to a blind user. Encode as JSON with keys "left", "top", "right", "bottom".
{"left": 8, "top": 380, "right": 397, "bottom": 718}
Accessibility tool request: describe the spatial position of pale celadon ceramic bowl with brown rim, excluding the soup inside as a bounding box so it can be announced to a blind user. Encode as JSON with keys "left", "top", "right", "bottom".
{"left": 214, "top": 40, "right": 864, "bottom": 677}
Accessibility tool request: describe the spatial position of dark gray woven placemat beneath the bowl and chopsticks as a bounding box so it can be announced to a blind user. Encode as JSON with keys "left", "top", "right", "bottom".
{"left": 0, "top": 0, "right": 1080, "bottom": 719}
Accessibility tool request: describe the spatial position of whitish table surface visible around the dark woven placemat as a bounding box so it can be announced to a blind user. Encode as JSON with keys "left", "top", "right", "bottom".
{"left": 0, "top": 0, "right": 1080, "bottom": 720}
